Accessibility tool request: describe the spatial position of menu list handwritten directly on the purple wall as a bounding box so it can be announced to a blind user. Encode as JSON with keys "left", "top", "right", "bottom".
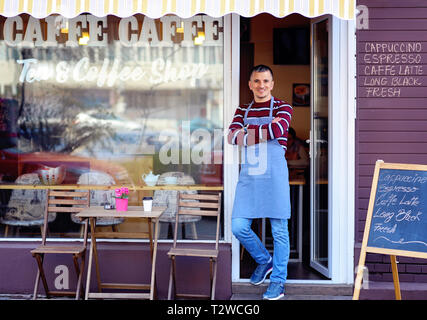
{"left": 361, "top": 42, "right": 424, "bottom": 98}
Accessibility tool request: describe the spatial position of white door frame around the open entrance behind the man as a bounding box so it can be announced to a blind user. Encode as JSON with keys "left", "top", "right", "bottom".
{"left": 229, "top": 14, "right": 356, "bottom": 284}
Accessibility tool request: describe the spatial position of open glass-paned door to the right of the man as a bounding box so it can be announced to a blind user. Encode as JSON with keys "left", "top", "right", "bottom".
{"left": 310, "top": 17, "right": 331, "bottom": 278}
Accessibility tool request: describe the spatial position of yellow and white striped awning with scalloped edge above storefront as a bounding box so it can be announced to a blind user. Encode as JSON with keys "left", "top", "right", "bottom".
{"left": 0, "top": 0, "right": 356, "bottom": 20}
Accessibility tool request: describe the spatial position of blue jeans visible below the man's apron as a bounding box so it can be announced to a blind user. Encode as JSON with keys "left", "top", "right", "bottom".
{"left": 231, "top": 218, "right": 290, "bottom": 283}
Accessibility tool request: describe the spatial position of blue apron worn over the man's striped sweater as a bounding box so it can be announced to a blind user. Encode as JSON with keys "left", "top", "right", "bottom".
{"left": 232, "top": 97, "right": 291, "bottom": 219}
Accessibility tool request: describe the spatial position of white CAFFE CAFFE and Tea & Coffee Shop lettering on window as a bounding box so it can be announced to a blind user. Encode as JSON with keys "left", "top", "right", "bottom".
{"left": 3, "top": 15, "right": 223, "bottom": 87}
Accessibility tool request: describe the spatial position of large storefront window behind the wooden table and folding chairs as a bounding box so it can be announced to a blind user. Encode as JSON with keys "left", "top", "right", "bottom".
{"left": 0, "top": 14, "right": 224, "bottom": 239}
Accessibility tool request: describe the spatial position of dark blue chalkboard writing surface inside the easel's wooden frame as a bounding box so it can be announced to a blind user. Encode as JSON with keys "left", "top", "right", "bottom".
{"left": 368, "top": 169, "right": 427, "bottom": 252}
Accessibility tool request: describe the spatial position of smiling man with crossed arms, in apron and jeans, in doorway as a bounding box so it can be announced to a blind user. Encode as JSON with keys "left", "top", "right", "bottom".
{"left": 228, "top": 65, "right": 292, "bottom": 300}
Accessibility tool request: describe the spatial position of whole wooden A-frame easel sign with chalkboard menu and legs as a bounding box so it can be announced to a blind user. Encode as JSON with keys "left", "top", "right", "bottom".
{"left": 353, "top": 160, "right": 427, "bottom": 300}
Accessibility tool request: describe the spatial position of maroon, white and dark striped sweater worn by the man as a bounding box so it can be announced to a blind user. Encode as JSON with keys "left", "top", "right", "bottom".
{"left": 228, "top": 98, "right": 293, "bottom": 151}
